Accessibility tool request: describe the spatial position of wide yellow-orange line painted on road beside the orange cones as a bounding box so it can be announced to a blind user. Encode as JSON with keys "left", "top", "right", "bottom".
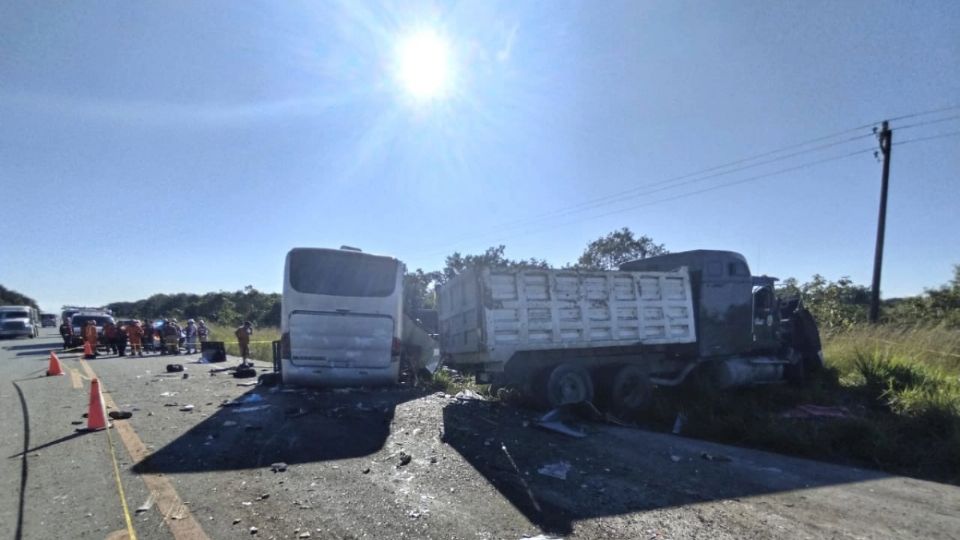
{"left": 80, "top": 358, "right": 209, "bottom": 540}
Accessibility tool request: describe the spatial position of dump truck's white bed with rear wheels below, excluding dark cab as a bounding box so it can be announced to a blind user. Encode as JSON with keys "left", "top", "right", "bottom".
{"left": 439, "top": 268, "right": 697, "bottom": 406}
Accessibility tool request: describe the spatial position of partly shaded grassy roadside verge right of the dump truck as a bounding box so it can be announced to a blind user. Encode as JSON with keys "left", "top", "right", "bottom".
{"left": 648, "top": 326, "right": 960, "bottom": 484}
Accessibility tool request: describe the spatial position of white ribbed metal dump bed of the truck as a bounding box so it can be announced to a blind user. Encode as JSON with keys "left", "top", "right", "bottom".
{"left": 439, "top": 268, "right": 696, "bottom": 362}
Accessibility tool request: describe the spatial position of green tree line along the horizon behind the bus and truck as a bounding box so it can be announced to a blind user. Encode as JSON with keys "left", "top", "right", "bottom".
{"left": 99, "top": 227, "right": 960, "bottom": 330}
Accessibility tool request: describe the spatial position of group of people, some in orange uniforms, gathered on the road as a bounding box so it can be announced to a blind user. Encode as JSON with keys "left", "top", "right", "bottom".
{"left": 60, "top": 319, "right": 210, "bottom": 356}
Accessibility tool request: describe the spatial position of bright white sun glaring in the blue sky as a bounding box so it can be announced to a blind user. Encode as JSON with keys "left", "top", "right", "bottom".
{"left": 397, "top": 31, "right": 452, "bottom": 100}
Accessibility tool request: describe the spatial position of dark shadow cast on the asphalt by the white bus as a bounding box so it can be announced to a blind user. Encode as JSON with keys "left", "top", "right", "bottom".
{"left": 133, "top": 387, "right": 423, "bottom": 473}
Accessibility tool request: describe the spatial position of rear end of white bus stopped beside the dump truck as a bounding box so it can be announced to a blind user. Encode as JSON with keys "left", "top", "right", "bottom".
{"left": 280, "top": 247, "right": 405, "bottom": 386}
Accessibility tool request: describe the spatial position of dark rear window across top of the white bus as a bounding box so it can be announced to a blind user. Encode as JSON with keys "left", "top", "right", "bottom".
{"left": 289, "top": 250, "right": 399, "bottom": 297}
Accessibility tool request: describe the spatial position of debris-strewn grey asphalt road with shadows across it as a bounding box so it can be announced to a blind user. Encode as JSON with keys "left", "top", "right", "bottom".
{"left": 0, "top": 331, "right": 960, "bottom": 540}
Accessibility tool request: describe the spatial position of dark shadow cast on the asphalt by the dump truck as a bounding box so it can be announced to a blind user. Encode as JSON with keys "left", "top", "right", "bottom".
{"left": 443, "top": 401, "right": 886, "bottom": 535}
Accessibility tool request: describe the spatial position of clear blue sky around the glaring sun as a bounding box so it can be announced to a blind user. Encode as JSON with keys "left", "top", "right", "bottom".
{"left": 0, "top": 0, "right": 960, "bottom": 310}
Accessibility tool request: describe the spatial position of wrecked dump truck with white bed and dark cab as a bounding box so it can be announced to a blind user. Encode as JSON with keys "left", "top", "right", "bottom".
{"left": 438, "top": 250, "right": 823, "bottom": 412}
